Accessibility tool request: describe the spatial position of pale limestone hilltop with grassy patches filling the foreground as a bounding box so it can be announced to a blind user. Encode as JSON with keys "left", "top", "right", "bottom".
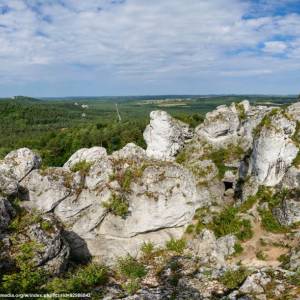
{"left": 0, "top": 100, "right": 300, "bottom": 299}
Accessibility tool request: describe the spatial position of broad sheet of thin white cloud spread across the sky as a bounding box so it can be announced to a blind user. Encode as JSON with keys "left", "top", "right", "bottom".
{"left": 0, "top": 0, "right": 300, "bottom": 94}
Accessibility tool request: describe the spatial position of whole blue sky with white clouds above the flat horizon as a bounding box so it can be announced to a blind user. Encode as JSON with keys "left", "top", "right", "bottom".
{"left": 0, "top": 0, "right": 300, "bottom": 97}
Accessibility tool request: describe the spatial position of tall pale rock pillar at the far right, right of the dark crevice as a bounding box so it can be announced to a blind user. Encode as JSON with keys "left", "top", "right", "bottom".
{"left": 249, "top": 112, "right": 298, "bottom": 186}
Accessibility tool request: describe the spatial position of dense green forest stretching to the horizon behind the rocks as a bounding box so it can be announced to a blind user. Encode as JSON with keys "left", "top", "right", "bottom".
{"left": 0, "top": 96, "right": 296, "bottom": 166}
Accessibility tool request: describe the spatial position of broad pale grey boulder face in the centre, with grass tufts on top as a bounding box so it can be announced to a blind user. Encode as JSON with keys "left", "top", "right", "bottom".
{"left": 9, "top": 144, "right": 203, "bottom": 264}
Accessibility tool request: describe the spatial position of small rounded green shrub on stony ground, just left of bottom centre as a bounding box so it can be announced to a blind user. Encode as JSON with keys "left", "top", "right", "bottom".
{"left": 118, "top": 255, "right": 147, "bottom": 279}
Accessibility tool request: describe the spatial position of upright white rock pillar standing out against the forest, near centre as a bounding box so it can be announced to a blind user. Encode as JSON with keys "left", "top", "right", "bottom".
{"left": 144, "top": 111, "right": 192, "bottom": 160}
